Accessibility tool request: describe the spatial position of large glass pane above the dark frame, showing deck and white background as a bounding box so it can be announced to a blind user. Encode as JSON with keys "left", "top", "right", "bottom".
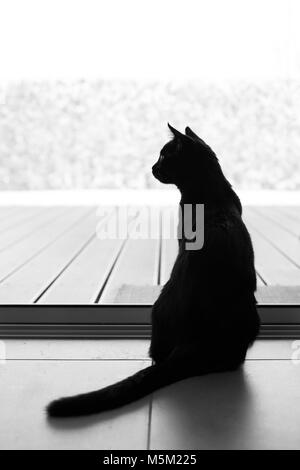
{"left": 0, "top": 0, "right": 300, "bottom": 318}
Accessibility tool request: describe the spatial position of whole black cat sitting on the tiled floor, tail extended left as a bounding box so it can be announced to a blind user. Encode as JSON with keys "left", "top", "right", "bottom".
{"left": 47, "top": 125, "right": 259, "bottom": 417}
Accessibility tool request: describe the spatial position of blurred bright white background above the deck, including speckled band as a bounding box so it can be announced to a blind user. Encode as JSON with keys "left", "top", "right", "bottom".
{"left": 0, "top": 0, "right": 300, "bottom": 190}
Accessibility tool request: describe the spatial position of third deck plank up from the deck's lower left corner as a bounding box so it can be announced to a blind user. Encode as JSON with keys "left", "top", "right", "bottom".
{"left": 0, "top": 207, "right": 66, "bottom": 251}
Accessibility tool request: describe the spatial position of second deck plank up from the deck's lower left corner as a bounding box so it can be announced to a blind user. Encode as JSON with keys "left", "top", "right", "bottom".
{"left": 0, "top": 207, "right": 90, "bottom": 281}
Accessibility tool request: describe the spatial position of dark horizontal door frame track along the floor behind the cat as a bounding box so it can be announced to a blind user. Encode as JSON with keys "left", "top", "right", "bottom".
{"left": 0, "top": 304, "right": 300, "bottom": 339}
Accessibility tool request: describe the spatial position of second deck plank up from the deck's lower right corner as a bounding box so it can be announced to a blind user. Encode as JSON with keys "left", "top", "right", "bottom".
{"left": 245, "top": 207, "right": 300, "bottom": 267}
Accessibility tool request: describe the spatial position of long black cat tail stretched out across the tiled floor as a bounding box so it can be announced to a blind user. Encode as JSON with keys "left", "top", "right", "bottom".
{"left": 46, "top": 358, "right": 193, "bottom": 418}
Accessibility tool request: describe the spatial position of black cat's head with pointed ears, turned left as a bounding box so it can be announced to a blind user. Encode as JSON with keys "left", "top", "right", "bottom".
{"left": 152, "top": 124, "right": 224, "bottom": 192}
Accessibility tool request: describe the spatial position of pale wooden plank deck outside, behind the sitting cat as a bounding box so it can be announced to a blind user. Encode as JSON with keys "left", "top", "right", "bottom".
{"left": 0, "top": 207, "right": 300, "bottom": 336}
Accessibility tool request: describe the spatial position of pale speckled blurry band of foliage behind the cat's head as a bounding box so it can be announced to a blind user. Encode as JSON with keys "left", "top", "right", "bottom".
{"left": 0, "top": 79, "right": 300, "bottom": 190}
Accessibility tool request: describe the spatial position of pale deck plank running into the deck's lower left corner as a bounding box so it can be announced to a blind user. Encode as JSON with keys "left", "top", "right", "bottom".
{"left": 0, "top": 211, "right": 97, "bottom": 303}
